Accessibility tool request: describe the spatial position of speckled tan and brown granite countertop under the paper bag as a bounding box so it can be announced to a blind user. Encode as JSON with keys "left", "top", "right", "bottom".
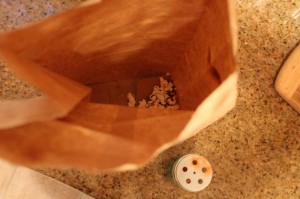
{"left": 0, "top": 0, "right": 300, "bottom": 199}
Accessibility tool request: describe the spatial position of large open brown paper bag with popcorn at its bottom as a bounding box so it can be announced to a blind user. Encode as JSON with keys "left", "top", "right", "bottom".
{"left": 0, "top": 0, "right": 237, "bottom": 170}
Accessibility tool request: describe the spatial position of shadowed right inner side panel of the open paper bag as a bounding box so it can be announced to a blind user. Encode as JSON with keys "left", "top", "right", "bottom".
{"left": 174, "top": 1, "right": 235, "bottom": 109}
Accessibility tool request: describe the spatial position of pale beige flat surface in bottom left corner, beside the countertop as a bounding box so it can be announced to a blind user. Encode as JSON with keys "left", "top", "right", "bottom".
{"left": 0, "top": 159, "right": 92, "bottom": 199}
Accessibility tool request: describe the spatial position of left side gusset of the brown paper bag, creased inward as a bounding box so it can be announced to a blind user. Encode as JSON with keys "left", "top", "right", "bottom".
{"left": 0, "top": 48, "right": 90, "bottom": 129}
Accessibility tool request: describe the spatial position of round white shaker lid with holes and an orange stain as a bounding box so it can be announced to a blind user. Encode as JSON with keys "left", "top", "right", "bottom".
{"left": 172, "top": 154, "right": 213, "bottom": 192}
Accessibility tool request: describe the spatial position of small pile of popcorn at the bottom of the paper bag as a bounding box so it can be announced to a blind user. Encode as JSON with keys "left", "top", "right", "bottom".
{"left": 127, "top": 77, "right": 179, "bottom": 110}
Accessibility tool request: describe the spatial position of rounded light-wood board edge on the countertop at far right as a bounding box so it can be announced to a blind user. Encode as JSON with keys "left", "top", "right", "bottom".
{"left": 275, "top": 45, "right": 300, "bottom": 113}
